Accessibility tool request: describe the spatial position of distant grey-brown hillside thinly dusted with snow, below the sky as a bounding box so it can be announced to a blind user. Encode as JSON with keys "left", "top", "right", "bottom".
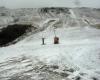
{"left": 0, "top": 7, "right": 100, "bottom": 27}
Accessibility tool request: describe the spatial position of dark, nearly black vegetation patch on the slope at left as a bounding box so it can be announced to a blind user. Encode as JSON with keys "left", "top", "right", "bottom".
{"left": 0, "top": 24, "right": 33, "bottom": 46}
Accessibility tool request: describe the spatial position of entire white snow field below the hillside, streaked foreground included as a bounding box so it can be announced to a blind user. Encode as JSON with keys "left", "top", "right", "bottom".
{"left": 0, "top": 26, "right": 100, "bottom": 80}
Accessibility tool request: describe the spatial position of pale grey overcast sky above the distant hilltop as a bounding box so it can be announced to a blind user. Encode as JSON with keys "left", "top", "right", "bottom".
{"left": 0, "top": 0, "right": 100, "bottom": 8}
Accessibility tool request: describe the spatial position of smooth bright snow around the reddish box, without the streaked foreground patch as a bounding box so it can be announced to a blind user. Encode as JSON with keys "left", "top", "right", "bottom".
{"left": 0, "top": 27, "right": 100, "bottom": 80}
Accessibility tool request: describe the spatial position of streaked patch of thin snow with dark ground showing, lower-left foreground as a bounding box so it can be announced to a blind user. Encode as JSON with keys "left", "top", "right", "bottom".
{"left": 0, "top": 56, "right": 74, "bottom": 80}
